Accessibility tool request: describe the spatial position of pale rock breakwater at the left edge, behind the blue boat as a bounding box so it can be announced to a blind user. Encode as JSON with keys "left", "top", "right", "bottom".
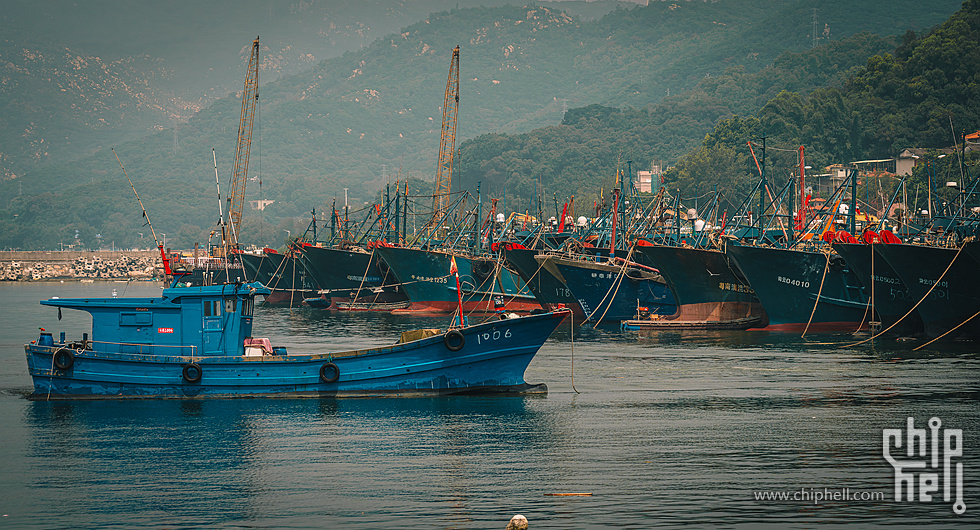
{"left": 0, "top": 250, "right": 162, "bottom": 281}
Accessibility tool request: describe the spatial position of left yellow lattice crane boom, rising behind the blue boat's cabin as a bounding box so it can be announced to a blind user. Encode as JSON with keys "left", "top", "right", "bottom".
{"left": 228, "top": 37, "right": 259, "bottom": 248}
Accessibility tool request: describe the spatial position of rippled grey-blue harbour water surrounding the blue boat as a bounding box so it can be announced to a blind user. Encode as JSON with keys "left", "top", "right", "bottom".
{"left": 0, "top": 283, "right": 980, "bottom": 530}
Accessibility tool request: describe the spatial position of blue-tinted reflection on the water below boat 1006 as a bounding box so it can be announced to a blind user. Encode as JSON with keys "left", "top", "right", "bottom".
{"left": 24, "top": 396, "right": 556, "bottom": 528}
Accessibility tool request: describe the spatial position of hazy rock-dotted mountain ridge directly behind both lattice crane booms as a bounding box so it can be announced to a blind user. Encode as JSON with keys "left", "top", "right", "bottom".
{"left": 0, "top": 0, "right": 958, "bottom": 247}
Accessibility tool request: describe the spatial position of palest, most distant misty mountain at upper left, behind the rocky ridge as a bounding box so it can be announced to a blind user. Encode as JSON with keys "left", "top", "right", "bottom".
{"left": 0, "top": 0, "right": 620, "bottom": 179}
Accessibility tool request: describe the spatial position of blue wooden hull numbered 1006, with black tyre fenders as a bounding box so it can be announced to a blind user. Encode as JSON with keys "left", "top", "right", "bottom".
{"left": 25, "top": 311, "right": 568, "bottom": 400}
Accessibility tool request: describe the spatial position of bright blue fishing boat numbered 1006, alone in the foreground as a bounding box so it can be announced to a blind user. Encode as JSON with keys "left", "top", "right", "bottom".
{"left": 25, "top": 283, "right": 568, "bottom": 400}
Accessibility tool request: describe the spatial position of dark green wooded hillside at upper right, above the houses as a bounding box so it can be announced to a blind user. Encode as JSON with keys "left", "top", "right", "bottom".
{"left": 666, "top": 0, "right": 980, "bottom": 210}
